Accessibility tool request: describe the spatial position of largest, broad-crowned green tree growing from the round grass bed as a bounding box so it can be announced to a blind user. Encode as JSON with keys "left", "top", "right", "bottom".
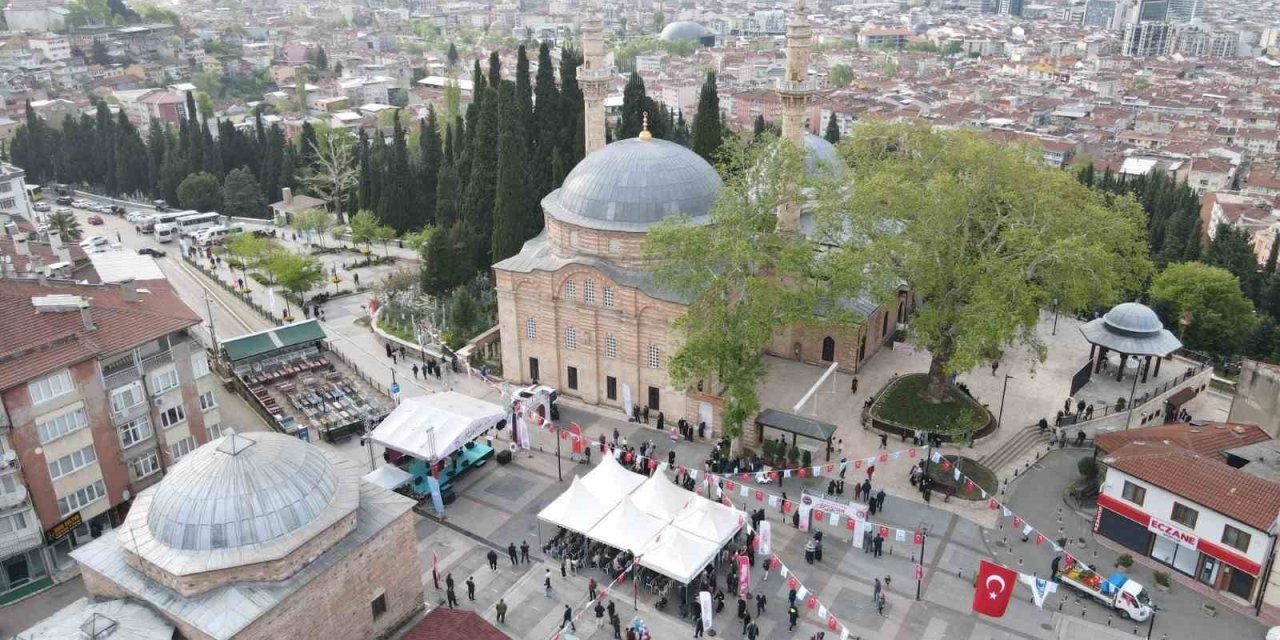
{"left": 818, "top": 124, "right": 1151, "bottom": 402}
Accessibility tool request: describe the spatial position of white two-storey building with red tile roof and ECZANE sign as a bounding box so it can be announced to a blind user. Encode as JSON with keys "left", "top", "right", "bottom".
{"left": 1093, "top": 422, "right": 1280, "bottom": 608}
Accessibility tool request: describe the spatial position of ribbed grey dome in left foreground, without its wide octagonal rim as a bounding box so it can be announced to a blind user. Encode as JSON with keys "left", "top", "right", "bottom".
{"left": 146, "top": 433, "right": 358, "bottom": 552}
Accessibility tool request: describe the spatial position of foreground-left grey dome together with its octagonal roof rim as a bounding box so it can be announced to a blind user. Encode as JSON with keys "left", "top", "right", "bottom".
{"left": 118, "top": 433, "right": 360, "bottom": 586}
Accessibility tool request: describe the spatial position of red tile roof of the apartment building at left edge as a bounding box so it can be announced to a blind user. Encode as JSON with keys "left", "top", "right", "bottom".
{"left": 0, "top": 279, "right": 201, "bottom": 390}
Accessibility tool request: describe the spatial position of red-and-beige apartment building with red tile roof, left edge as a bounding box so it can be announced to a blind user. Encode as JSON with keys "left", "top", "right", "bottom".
{"left": 0, "top": 279, "right": 213, "bottom": 604}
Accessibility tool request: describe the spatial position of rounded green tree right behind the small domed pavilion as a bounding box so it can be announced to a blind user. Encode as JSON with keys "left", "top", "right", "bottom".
{"left": 1149, "top": 262, "right": 1257, "bottom": 357}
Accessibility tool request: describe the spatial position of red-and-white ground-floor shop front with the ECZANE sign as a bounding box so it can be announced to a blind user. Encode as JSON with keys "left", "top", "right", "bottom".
{"left": 1093, "top": 493, "right": 1262, "bottom": 603}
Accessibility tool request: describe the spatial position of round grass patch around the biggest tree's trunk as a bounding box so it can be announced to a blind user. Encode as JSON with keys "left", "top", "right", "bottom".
{"left": 872, "top": 374, "right": 987, "bottom": 435}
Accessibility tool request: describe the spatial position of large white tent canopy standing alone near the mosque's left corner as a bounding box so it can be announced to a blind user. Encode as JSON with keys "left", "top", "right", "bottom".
{"left": 369, "top": 392, "right": 508, "bottom": 462}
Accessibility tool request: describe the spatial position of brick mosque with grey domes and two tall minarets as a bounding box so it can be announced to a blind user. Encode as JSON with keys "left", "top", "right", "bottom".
{"left": 493, "top": 0, "right": 913, "bottom": 443}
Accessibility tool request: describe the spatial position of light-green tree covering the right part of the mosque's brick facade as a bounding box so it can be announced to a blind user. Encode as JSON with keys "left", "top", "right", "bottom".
{"left": 646, "top": 142, "right": 824, "bottom": 436}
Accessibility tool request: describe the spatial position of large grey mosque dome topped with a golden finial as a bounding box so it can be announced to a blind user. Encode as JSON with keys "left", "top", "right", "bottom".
{"left": 543, "top": 138, "right": 721, "bottom": 232}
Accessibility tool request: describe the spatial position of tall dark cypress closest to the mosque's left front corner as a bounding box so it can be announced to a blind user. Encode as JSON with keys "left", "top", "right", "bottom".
{"left": 490, "top": 82, "right": 530, "bottom": 261}
